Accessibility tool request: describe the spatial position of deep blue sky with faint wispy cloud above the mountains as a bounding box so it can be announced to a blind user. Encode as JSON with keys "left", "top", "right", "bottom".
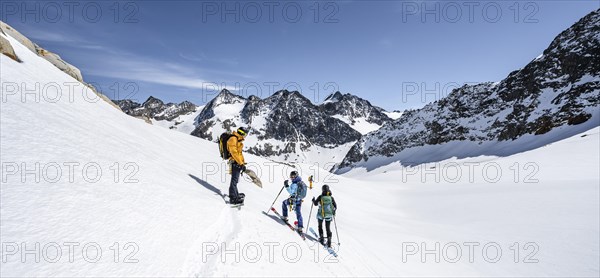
{"left": 0, "top": 0, "right": 600, "bottom": 110}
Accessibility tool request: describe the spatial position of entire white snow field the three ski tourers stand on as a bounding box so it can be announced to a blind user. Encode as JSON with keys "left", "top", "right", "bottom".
{"left": 0, "top": 29, "right": 600, "bottom": 277}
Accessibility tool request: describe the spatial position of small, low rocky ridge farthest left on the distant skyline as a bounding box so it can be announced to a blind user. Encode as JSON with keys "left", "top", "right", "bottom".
{"left": 113, "top": 96, "right": 197, "bottom": 121}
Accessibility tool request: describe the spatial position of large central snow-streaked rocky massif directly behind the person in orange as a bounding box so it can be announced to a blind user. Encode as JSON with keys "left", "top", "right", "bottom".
{"left": 192, "top": 90, "right": 361, "bottom": 157}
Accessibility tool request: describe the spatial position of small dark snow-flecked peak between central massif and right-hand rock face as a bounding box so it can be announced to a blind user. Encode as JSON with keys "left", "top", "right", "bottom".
{"left": 319, "top": 92, "right": 392, "bottom": 125}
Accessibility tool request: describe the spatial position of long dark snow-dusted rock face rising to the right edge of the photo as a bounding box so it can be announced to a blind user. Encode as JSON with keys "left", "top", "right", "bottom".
{"left": 340, "top": 10, "right": 600, "bottom": 167}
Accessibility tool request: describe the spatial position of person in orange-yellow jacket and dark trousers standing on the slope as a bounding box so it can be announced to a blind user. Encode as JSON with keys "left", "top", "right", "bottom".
{"left": 227, "top": 127, "right": 248, "bottom": 204}
